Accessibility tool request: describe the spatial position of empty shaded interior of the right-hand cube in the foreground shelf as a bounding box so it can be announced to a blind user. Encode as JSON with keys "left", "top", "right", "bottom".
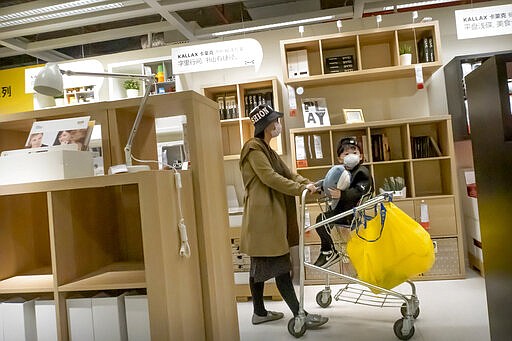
{"left": 52, "top": 185, "right": 144, "bottom": 290}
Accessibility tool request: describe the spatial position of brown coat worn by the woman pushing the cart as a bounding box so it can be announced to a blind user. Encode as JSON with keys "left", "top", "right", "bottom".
{"left": 240, "top": 138, "right": 309, "bottom": 257}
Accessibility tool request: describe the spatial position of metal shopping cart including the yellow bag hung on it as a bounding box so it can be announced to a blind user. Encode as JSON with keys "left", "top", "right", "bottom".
{"left": 288, "top": 190, "right": 434, "bottom": 340}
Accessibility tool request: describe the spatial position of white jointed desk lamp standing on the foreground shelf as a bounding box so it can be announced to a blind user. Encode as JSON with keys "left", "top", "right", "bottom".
{"left": 34, "top": 63, "right": 155, "bottom": 173}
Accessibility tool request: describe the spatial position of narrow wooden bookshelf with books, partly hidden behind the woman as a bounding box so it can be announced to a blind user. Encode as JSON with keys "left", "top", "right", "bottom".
{"left": 203, "top": 78, "right": 284, "bottom": 301}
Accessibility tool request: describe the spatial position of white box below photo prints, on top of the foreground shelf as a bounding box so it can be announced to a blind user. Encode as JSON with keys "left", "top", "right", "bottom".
{"left": 0, "top": 150, "right": 94, "bottom": 185}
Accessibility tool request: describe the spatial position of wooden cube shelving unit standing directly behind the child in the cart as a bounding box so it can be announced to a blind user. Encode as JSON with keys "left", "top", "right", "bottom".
{"left": 290, "top": 116, "right": 465, "bottom": 284}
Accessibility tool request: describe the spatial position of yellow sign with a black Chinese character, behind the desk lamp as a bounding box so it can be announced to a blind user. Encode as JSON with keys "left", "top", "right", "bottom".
{"left": 0, "top": 65, "right": 40, "bottom": 114}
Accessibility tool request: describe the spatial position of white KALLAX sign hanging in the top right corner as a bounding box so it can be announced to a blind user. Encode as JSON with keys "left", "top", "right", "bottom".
{"left": 455, "top": 5, "right": 512, "bottom": 39}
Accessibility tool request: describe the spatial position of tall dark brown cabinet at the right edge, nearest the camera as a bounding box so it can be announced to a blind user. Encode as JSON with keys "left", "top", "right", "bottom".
{"left": 466, "top": 53, "right": 512, "bottom": 340}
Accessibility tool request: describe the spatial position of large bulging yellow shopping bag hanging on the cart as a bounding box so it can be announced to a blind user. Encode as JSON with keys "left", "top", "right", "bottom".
{"left": 347, "top": 202, "right": 435, "bottom": 293}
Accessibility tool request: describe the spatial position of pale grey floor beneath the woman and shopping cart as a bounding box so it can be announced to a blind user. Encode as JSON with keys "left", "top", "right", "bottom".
{"left": 238, "top": 269, "right": 490, "bottom": 341}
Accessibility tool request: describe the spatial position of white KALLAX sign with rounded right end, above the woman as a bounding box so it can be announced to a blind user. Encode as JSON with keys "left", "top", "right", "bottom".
{"left": 172, "top": 38, "right": 263, "bottom": 75}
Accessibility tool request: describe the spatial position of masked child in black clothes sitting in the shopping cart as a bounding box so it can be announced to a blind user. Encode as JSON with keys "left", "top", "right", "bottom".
{"left": 314, "top": 137, "right": 373, "bottom": 268}
